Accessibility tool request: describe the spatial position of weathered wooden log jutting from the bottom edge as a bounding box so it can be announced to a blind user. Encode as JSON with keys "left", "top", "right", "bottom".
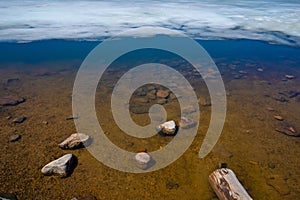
{"left": 208, "top": 168, "right": 252, "bottom": 200}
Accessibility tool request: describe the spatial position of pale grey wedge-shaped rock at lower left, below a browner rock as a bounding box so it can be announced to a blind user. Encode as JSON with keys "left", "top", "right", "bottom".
{"left": 41, "top": 154, "right": 76, "bottom": 177}
